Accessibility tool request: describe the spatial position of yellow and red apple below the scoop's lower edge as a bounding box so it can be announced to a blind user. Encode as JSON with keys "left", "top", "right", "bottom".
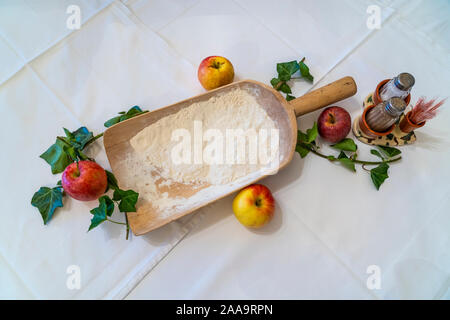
{"left": 233, "top": 184, "right": 275, "bottom": 228}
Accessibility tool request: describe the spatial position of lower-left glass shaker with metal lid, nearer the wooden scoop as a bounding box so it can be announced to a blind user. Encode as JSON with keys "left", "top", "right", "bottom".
{"left": 366, "top": 97, "right": 406, "bottom": 132}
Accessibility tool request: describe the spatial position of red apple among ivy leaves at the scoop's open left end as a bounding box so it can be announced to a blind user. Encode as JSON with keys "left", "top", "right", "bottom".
{"left": 62, "top": 161, "right": 108, "bottom": 201}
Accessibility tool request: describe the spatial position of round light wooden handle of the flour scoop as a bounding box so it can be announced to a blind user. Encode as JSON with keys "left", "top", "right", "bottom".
{"left": 289, "top": 77, "right": 357, "bottom": 117}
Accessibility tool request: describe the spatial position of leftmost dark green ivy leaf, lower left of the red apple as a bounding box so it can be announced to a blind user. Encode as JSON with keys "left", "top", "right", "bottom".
{"left": 31, "top": 187, "right": 63, "bottom": 224}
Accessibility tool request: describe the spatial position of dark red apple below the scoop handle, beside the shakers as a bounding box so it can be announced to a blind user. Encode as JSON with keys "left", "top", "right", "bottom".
{"left": 317, "top": 106, "right": 352, "bottom": 143}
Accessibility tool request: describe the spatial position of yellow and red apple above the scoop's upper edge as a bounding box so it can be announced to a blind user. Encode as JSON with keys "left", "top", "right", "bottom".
{"left": 197, "top": 56, "right": 234, "bottom": 90}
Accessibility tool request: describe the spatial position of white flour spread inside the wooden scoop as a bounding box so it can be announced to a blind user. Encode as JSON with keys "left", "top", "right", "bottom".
{"left": 118, "top": 89, "right": 276, "bottom": 216}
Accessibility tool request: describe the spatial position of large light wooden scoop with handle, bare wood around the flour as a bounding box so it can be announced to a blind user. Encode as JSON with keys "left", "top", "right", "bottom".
{"left": 103, "top": 77, "right": 357, "bottom": 235}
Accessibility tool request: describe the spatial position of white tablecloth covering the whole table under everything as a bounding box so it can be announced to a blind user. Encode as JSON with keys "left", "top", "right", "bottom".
{"left": 0, "top": 0, "right": 450, "bottom": 299}
